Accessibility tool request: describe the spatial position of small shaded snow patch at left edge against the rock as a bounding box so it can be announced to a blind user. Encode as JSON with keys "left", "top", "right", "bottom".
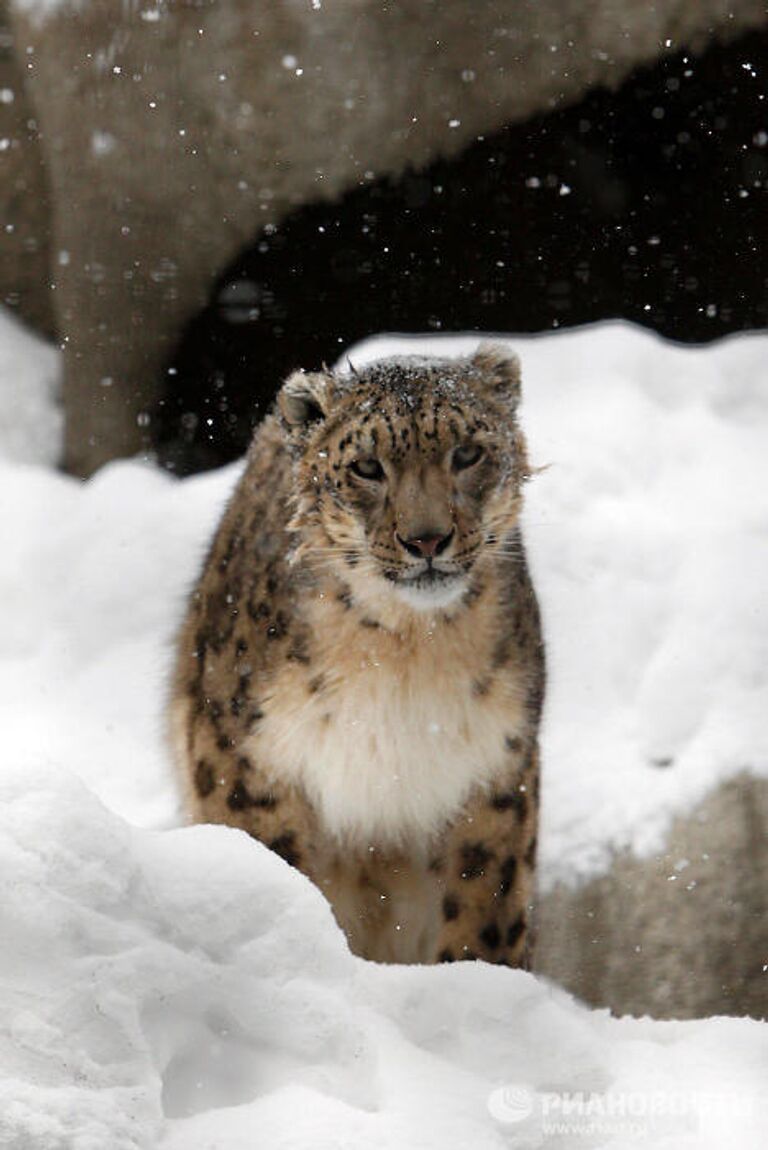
{"left": 0, "top": 308, "right": 63, "bottom": 465}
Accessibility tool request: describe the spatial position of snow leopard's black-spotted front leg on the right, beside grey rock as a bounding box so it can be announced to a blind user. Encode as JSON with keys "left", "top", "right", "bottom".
{"left": 433, "top": 739, "right": 538, "bottom": 966}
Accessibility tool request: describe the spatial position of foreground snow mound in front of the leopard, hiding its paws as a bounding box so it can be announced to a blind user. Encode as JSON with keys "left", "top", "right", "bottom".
{"left": 0, "top": 769, "right": 768, "bottom": 1150}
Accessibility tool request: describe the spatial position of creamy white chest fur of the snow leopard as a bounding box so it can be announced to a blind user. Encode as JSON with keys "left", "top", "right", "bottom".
{"left": 248, "top": 621, "right": 524, "bottom": 844}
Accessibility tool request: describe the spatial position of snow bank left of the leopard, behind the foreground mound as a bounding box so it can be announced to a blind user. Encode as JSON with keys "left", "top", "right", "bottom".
{"left": 0, "top": 450, "right": 235, "bottom": 827}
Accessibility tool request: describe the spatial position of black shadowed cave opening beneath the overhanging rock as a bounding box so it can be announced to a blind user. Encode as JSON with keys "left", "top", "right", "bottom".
{"left": 158, "top": 32, "right": 768, "bottom": 474}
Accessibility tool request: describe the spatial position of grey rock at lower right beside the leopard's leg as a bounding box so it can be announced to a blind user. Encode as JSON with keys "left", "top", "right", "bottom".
{"left": 536, "top": 775, "right": 768, "bottom": 1018}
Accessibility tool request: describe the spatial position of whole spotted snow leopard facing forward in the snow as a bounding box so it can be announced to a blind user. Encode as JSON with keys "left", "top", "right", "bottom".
{"left": 171, "top": 345, "right": 544, "bottom": 965}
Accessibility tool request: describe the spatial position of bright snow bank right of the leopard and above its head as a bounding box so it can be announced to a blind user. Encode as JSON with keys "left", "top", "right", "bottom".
{"left": 350, "top": 323, "right": 768, "bottom": 883}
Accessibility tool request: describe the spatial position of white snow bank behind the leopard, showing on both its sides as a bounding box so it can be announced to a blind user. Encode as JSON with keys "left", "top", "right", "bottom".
{"left": 0, "top": 324, "right": 768, "bottom": 883}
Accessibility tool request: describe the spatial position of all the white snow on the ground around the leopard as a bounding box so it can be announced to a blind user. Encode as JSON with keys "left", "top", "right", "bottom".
{"left": 0, "top": 310, "right": 768, "bottom": 1150}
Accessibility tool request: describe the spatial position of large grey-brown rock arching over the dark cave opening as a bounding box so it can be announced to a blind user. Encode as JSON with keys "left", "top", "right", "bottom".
{"left": 7, "top": 0, "right": 766, "bottom": 475}
